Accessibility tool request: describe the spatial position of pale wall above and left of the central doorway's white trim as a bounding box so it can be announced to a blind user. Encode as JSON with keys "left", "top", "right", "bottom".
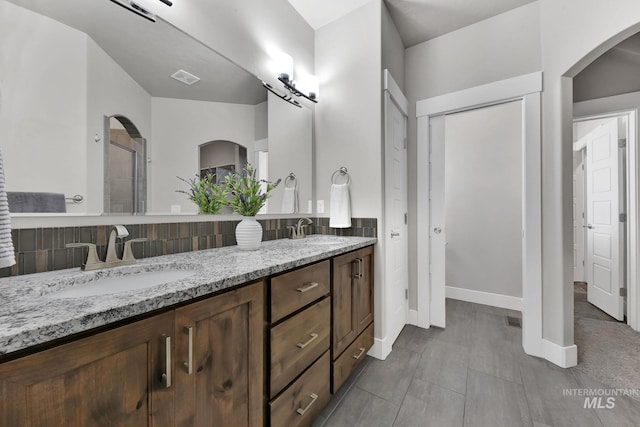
{"left": 405, "top": 2, "right": 542, "bottom": 309}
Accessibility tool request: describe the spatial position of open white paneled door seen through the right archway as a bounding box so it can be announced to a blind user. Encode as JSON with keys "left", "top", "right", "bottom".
{"left": 586, "top": 120, "right": 624, "bottom": 320}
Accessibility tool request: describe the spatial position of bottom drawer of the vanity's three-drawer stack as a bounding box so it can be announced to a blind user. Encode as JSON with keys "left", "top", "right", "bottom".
{"left": 269, "top": 351, "right": 331, "bottom": 427}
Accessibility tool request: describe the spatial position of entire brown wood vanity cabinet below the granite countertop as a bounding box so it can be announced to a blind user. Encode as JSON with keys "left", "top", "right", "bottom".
{"left": 0, "top": 246, "right": 373, "bottom": 427}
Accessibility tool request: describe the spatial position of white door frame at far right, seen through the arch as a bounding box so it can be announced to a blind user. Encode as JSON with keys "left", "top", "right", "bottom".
{"left": 573, "top": 108, "right": 640, "bottom": 331}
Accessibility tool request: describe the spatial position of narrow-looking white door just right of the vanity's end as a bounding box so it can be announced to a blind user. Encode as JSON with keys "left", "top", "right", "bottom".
{"left": 385, "top": 92, "right": 409, "bottom": 342}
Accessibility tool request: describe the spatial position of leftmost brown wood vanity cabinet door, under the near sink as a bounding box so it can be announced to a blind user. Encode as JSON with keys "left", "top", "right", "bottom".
{"left": 0, "top": 313, "right": 174, "bottom": 427}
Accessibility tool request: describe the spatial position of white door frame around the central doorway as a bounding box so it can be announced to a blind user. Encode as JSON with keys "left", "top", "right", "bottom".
{"left": 416, "top": 72, "right": 545, "bottom": 357}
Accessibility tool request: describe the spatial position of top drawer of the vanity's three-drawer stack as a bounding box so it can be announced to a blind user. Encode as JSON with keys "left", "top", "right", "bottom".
{"left": 270, "top": 260, "right": 331, "bottom": 322}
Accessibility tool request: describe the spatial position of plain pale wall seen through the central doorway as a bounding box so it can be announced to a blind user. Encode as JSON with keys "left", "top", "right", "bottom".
{"left": 445, "top": 101, "right": 523, "bottom": 298}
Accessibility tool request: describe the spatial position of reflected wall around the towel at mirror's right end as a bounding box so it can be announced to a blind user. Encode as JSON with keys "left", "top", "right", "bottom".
{"left": 268, "top": 93, "right": 313, "bottom": 214}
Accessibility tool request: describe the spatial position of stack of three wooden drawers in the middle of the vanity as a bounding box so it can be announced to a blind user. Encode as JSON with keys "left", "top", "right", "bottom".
{"left": 267, "top": 260, "right": 331, "bottom": 427}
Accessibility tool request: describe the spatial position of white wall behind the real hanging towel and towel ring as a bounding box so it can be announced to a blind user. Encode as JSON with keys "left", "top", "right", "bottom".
{"left": 315, "top": 0, "right": 386, "bottom": 346}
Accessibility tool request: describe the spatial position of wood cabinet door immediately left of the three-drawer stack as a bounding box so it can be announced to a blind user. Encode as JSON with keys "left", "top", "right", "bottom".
{"left": 175, "top": 282, "right": 264, "bottom": 427}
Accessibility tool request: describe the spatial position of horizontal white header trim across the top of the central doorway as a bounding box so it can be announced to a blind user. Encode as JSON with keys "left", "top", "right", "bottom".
{"left": 416, "top": 71, "right": 542, "bottom": 117}
